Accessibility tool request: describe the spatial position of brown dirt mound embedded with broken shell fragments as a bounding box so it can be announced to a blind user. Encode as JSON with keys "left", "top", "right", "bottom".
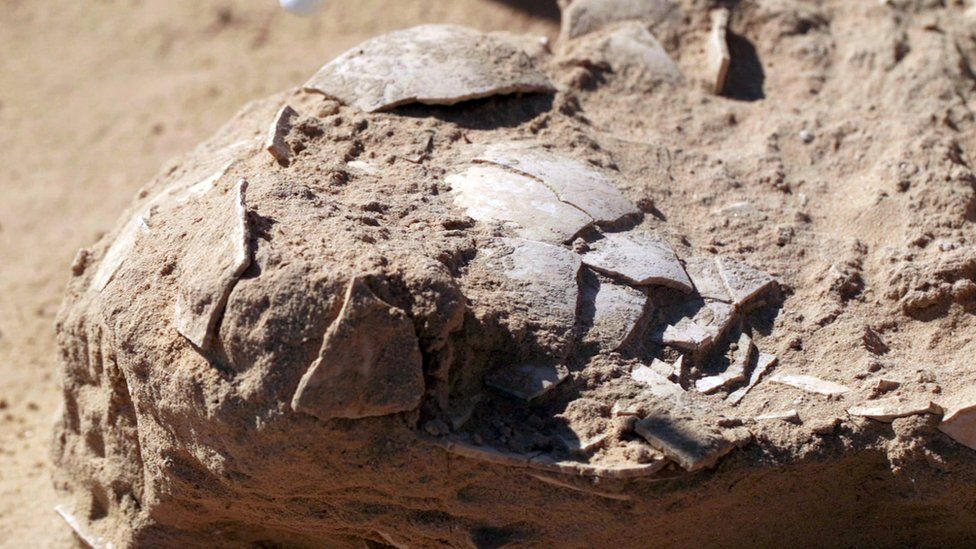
{"left": 55, "top": 0, "right": 976, "bottom": 547}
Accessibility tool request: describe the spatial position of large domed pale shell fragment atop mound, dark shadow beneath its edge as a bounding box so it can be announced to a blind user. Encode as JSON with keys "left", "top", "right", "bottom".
{"left": 305, "top": 25, "right": 555, "bottom": 112}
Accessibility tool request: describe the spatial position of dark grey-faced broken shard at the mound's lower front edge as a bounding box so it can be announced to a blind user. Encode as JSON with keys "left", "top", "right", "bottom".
{"left": 634, "top": 405, "right": 735, "bottom": 471}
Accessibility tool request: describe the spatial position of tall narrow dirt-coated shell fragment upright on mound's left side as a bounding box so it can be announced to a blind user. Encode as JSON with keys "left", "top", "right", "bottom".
{"left": 175, "top": 179, "right": 251, "bottom": 350}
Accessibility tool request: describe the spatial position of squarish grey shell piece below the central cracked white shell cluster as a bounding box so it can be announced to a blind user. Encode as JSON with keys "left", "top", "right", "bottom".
{"left": 582, "top": 277, "right": 647, "bottom": 350}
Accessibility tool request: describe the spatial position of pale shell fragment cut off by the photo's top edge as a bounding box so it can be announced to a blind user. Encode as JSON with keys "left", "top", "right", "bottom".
{"left": 561, "top": 0, "right": 674, "bottom": 39}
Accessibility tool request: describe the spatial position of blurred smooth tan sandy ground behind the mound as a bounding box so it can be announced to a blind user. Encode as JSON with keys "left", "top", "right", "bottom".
{"left": 0, "top": 0, "right": 556, "bottom": 547}
